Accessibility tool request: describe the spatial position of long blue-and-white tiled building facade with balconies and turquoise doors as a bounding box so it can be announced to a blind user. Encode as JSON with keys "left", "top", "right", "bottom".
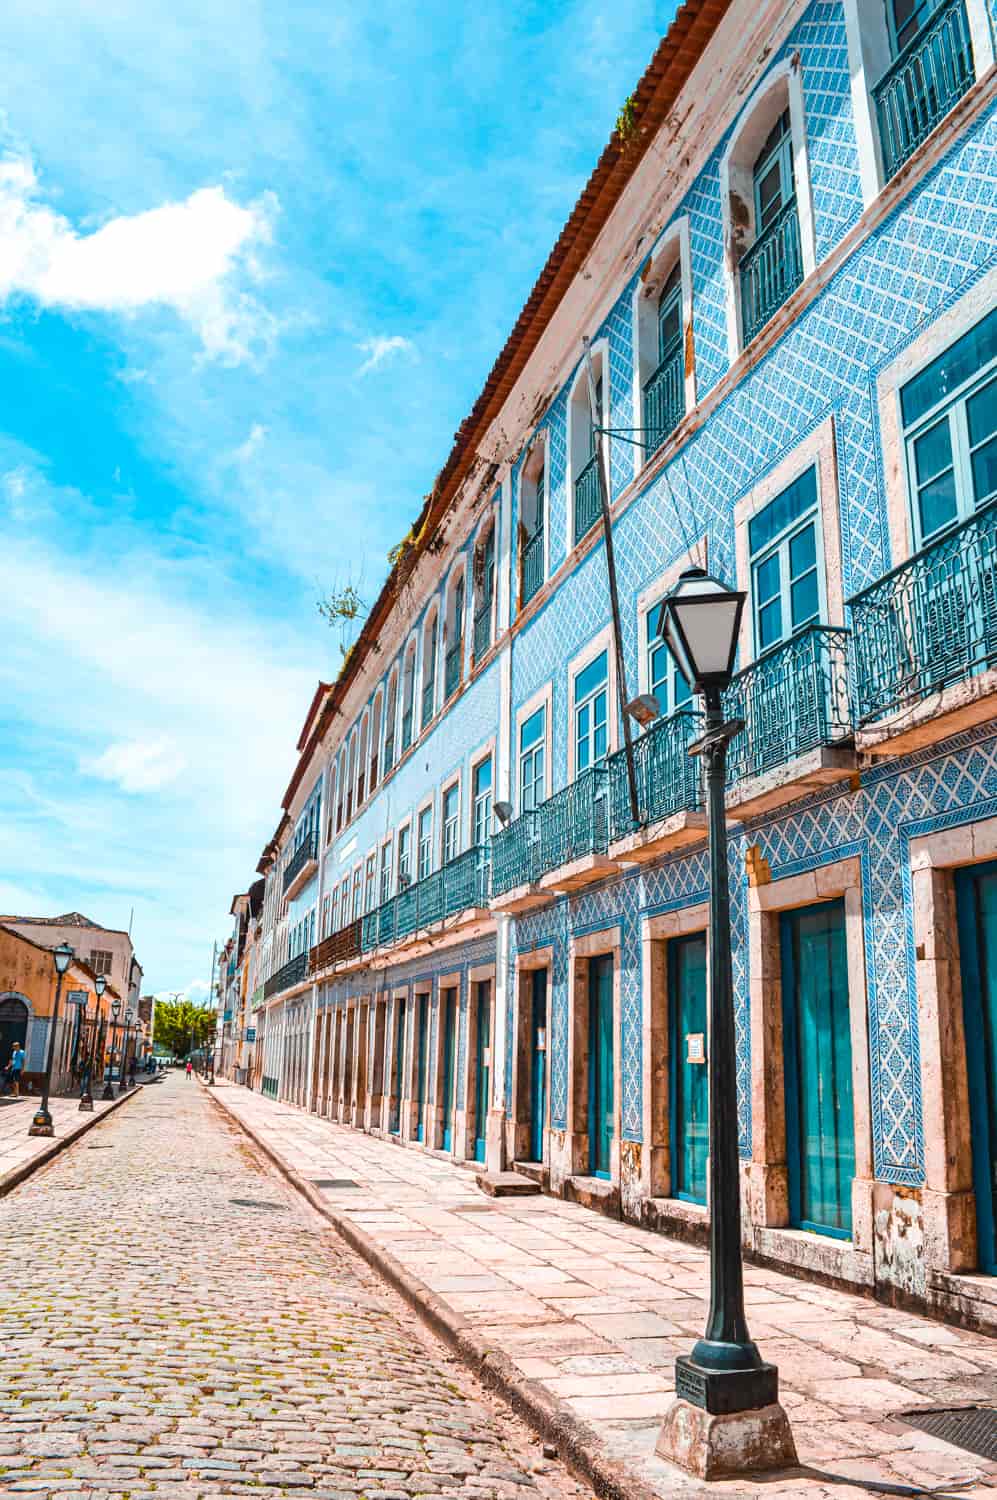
{"left": 242, "top": 0, "right": 997, "bottom": 1322}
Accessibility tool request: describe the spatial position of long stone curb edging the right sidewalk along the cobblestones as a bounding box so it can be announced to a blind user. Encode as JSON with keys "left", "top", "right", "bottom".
{"left": 202, "top": 1085, "right": 677, "bottom": 1500}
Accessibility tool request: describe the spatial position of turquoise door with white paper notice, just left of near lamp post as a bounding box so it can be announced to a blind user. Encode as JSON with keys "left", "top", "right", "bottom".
{"left": 669, "top": 933, "right": 709, "bottom": 1205}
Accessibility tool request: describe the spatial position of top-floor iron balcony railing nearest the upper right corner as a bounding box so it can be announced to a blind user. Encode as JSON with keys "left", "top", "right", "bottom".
{"left": 873, "top": 0, "right": 975, "bottom": 182}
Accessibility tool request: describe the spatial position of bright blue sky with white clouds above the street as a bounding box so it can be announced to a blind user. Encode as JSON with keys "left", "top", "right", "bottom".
{"left": 0, "top": 0, "right": 675, "bottom": 995}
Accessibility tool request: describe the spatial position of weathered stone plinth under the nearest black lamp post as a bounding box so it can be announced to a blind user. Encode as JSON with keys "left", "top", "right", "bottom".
{"left": 655, "top": 1398, "right": 798, "bottom": 1479}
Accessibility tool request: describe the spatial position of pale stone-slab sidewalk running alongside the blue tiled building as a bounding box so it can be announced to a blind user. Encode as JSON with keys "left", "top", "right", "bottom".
{"left": 214, "top": 1082, "right": 997, "bottom": 1500}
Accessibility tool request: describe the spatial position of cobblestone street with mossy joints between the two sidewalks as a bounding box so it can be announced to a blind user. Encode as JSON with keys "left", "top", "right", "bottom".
{"left": 0, "top": 1074, "right": 589, "bottom": 1500}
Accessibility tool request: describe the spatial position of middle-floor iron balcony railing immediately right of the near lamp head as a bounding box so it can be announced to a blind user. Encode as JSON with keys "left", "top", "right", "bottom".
{"left": 724, "top": 626, "right": 853, "bottom": 786}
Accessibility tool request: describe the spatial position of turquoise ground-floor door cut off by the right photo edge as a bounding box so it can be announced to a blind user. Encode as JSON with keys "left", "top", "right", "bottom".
{"left": 955, "top": 864, "right": 997, "bottom": 1277}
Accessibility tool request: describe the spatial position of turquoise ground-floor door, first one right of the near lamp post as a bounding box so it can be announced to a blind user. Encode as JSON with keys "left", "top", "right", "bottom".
{"left": 781, "top": 900, "right": 855, "bottom": 1239}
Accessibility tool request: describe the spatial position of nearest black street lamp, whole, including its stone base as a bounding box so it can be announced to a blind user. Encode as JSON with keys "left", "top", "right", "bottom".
{"left": 658, "top": 569, "right": 796, "bottom": 1479}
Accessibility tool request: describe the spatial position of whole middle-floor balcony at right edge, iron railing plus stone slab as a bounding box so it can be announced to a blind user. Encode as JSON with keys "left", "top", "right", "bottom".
{"left": 850, "top": 501, "right": 997, "bottom": 755}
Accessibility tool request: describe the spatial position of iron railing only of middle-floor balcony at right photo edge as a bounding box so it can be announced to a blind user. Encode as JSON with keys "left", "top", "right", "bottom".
{"left": 849, "top": 501, "right": 997, "bottom": 725}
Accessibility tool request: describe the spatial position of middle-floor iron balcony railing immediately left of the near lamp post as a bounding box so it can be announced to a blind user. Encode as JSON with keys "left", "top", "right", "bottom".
{"left": 609, "top": 708, "right": 703, "bottom": 842}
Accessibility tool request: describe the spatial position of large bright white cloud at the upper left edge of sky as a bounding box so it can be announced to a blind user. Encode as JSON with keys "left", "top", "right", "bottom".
{"left": 0, "top": 155, "right": 277, "bottom": 363}
